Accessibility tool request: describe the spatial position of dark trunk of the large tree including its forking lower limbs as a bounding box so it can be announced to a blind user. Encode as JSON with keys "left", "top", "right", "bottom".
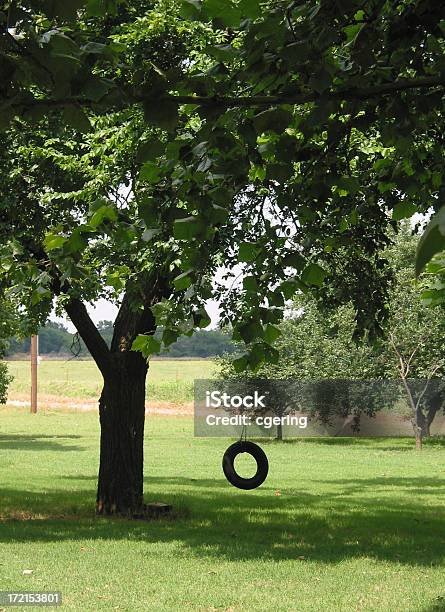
{"left": 65, "top": 285, "right": 166, "bottom": 516}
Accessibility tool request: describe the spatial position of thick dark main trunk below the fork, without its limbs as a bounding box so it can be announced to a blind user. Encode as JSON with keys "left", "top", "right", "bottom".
{"left": 96, "top": 352, "right": 148, "bottom": 516}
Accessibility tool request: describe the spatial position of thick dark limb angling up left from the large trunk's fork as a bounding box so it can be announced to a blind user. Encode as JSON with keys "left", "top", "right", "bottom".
{"left": 65, "top": 298, "right": 111, "bottom": 377}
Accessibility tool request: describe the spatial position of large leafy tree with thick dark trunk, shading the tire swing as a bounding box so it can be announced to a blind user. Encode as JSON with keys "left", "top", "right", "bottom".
{"left": 0, "top": 0, "right": 445, "bottom": 512}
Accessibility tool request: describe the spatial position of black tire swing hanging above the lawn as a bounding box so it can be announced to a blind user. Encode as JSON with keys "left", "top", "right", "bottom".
{"left": 222, "top": 437, "right": 269, "bottom": 490}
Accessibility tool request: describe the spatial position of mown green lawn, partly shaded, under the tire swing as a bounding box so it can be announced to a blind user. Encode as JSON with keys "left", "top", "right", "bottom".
{"left": 0, "top": 408, "right": 445, "bottom": 612}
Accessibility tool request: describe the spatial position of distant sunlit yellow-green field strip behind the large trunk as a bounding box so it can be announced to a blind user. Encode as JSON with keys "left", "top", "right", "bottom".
{"left": 8, "top": 360, "right": 215, "bottom": 403}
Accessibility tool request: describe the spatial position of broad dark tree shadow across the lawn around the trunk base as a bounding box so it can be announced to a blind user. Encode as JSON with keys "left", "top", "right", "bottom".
{"left": 0, "top": 476, "right": 445, "bottom": 568}
